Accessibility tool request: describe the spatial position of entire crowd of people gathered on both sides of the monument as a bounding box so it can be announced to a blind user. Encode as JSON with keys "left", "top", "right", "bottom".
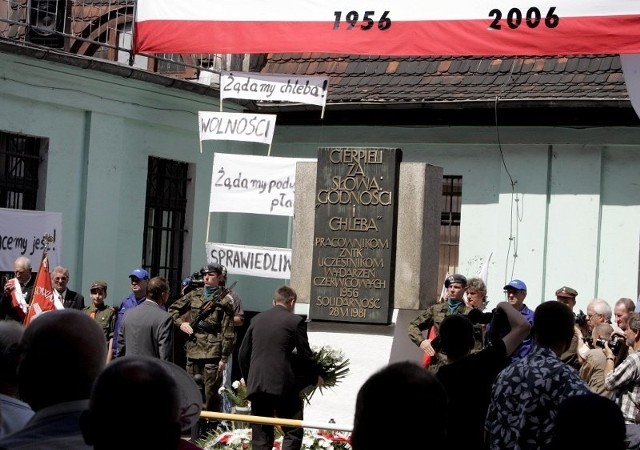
{"left": 0, "top": 253, "right": 640, "bottom": 450}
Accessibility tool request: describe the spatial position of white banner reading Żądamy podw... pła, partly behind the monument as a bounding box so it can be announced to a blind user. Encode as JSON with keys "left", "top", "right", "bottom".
{"left": 209, "top": 153, "right": 315, "bottom": 216}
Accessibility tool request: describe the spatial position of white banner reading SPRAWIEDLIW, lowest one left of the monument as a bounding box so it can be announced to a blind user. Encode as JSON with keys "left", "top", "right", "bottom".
{"left": 206, "top": 242, "right": 291, "bottom": 279}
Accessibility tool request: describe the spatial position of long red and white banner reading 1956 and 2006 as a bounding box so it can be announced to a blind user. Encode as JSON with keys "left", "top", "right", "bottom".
{"left": 134, "top": 0, "right": 640, "bottom": 56}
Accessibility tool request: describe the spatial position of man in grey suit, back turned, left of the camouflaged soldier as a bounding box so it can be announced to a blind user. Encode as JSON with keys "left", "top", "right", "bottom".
{"left": 116, "top": 277, "right": 173, "bottom": 361}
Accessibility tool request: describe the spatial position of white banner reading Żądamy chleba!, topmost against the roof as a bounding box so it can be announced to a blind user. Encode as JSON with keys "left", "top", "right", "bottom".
{"left": 220, "top": 71, "right": 329, "bottom": 106}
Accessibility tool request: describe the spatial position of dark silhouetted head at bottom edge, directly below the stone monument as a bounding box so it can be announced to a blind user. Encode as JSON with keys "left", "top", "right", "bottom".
{"left": 351, "top": 361, "right": 447, "bottom": 450}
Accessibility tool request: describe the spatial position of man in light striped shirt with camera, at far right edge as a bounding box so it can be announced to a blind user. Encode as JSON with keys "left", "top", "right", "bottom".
{"left": 604, "top": 312, "right": 640, "bottom": 449}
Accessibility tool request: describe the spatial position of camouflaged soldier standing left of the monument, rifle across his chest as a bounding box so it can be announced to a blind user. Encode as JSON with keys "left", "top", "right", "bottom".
{"left": 169, "top": 264, "right": 234, "bottom": 411}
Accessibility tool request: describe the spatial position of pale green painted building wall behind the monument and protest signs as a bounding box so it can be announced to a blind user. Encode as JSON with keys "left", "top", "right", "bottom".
{"left": 0, "top": 48, "right": 640, "bottom": 311}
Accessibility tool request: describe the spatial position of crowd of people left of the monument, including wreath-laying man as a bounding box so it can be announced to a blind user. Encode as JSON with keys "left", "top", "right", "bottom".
{"left": 0, "top": 257, "right": 322, "bottom": 450}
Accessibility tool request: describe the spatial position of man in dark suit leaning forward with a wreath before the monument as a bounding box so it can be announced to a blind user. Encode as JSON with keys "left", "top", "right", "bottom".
{"left": 238, "top": 286, "right": 324, "bottom": 450}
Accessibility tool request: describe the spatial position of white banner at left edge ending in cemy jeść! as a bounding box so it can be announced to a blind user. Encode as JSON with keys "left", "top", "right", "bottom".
{"left": 0, "top": 208, "right": 62, "bottom": 272}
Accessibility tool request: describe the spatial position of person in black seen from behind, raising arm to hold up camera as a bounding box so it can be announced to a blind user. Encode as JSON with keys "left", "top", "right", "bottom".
{"left": 436, "top": 302, "right": 531, "bottom": 450}
